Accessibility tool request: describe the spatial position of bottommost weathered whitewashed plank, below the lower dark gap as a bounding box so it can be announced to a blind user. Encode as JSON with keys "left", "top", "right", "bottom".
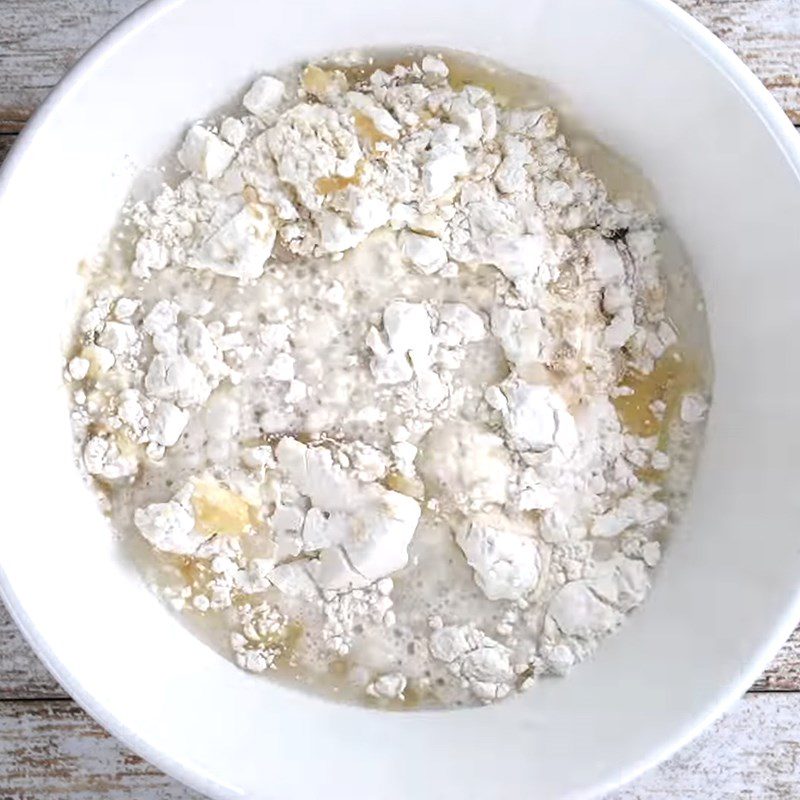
{"left": 0, "top": 693, "right": 800, "bottom": 800}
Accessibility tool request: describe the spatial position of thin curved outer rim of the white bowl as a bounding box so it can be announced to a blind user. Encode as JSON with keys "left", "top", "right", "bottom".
{"left": 0, "top": 0, "right": 800, "bottom": 800}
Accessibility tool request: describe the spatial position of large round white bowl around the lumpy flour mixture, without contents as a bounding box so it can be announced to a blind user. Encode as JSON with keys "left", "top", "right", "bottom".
{"left": 0, "top": 0, "right": 800, "bottom": 800}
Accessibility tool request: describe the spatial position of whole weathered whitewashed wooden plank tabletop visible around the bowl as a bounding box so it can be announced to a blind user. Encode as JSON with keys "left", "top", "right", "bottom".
{"left": 0, "top": 0, "right": 800, "bottom": 800}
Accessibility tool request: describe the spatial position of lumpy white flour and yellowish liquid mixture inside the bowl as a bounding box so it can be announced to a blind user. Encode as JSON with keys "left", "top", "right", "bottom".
{"left": 64, "top": 55, "right": 708, "bottom": 708}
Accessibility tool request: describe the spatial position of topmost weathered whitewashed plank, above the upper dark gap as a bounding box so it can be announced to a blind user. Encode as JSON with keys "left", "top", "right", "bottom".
{"left": 0, "top": 0, "right": 800, "bottom": 132}
